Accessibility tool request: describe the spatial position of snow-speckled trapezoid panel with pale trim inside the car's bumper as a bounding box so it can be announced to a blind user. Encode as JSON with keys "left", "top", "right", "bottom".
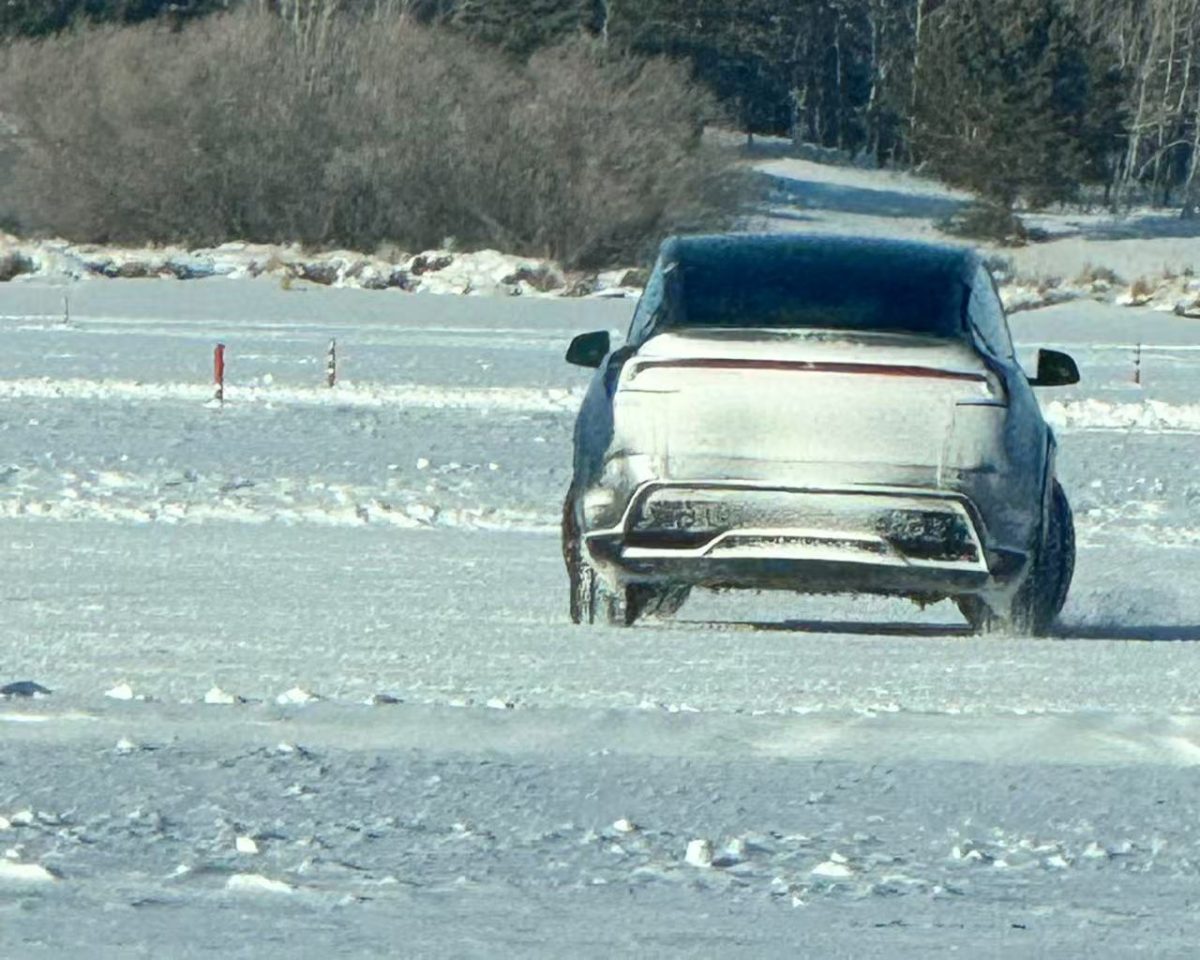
{"left": 624, "top": 486, "right": 980, "bottom": 564}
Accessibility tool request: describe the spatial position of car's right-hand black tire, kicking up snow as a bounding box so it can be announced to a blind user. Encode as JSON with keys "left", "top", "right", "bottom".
{"left": 958, "top": 480, "right": 1075, "bottom": 636}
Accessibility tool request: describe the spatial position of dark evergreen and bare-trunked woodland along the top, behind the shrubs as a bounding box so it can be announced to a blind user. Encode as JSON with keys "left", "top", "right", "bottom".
{"left": 7, "top": 0, "right": 1200, "bottom": 214}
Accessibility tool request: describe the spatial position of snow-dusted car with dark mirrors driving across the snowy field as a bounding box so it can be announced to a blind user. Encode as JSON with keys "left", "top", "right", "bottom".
{"left": 563, "top": 235, "right": 1079, "bottom": 634}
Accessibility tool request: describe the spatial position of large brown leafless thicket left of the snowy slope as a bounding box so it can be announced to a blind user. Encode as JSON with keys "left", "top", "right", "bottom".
{"left": 0, "top": 5, "right": 738, "bottom": 266}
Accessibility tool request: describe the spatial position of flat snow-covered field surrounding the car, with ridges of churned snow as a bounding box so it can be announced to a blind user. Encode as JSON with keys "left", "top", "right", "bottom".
{"left": 7, "top": 165, "right": 1200, "bottom": 958}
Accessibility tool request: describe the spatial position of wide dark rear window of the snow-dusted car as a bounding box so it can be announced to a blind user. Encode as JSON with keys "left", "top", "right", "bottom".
{"left": 658, "top": 245, "right": 967, "bottom": 338}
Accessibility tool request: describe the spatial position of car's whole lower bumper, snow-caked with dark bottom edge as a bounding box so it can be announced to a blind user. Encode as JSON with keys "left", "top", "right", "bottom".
{"left": 583, "top": 480, "right": 1026, "bottom": 596}
